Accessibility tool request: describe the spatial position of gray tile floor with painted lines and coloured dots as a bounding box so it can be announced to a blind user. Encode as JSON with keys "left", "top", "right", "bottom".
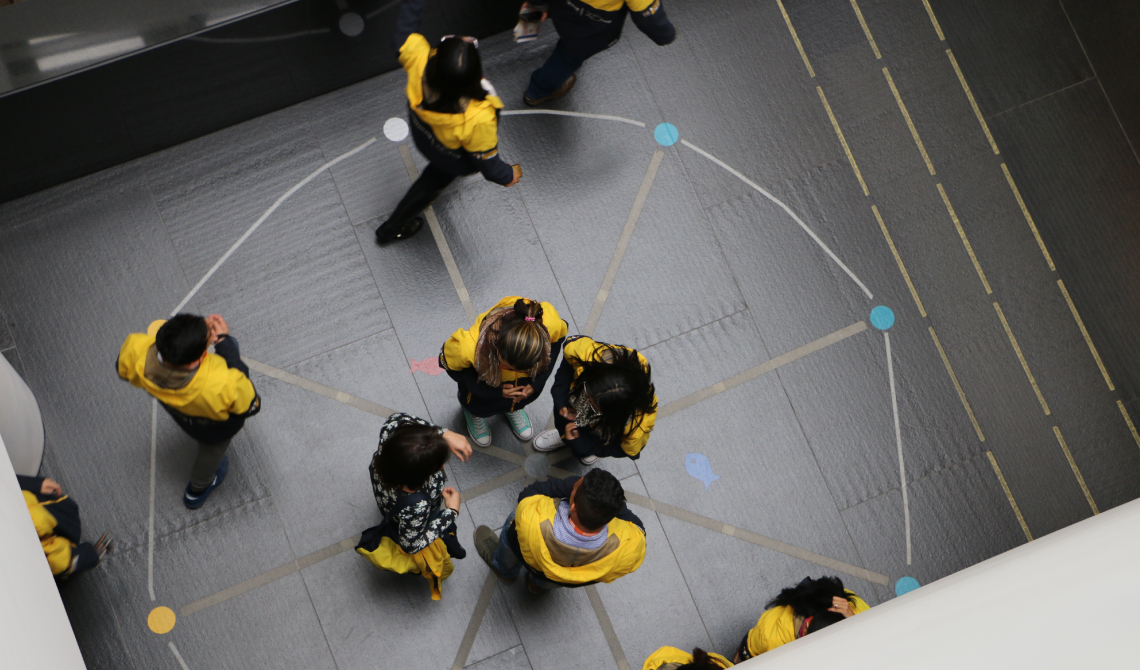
{"left": 0, "top": 0, "right": 1140, "bottom": 670}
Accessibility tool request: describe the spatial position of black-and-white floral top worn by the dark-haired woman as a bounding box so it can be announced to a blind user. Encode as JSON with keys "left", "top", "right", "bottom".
{"left": 368, "top": 412, "right": 455, "bottom": 554}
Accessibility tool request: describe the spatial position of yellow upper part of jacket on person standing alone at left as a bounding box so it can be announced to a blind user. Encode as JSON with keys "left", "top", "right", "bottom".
{"left": 119, "top": 320, "right": 258, "bottom": 422}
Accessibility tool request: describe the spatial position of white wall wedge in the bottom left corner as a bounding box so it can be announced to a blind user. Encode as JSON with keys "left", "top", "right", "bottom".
{"left": 0, "top": 430, "right": 86, "bottom": 670}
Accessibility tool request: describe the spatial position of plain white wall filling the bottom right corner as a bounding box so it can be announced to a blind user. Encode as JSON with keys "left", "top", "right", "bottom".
{"left": 740, "top": 500, "right": 1140, "bottom": 670}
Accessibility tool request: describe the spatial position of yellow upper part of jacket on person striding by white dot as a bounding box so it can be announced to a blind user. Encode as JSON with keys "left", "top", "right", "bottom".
{"left": 400, "top": 33, "right": 503, "bottom": 158}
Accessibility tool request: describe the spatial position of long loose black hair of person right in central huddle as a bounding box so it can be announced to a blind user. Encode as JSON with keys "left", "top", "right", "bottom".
{"left": 571, "top": 344, "right": 657, "bottom": 442}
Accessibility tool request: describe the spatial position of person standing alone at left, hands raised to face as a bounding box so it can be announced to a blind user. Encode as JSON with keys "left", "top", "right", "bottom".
{"left": 115, "top": 313, "right": 261, "bottom": 509}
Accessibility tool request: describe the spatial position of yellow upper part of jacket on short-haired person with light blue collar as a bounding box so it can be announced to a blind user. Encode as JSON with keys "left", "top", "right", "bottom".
{"left": 514, "top": 496, "right": 645, "bottom": 585}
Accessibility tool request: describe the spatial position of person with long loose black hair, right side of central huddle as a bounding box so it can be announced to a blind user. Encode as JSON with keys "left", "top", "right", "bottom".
{"left": 535, "top": 335, "right": 657, "bottom": 465}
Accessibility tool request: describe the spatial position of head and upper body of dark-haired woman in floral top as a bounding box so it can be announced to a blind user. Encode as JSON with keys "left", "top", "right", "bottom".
{"left": 368, "top": 414, "right": 471, "bottom": 558}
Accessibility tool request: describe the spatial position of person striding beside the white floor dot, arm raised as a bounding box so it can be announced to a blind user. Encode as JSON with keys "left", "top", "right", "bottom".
{"left": 376, "top": 0, "right": 522, "bottom": 244}
